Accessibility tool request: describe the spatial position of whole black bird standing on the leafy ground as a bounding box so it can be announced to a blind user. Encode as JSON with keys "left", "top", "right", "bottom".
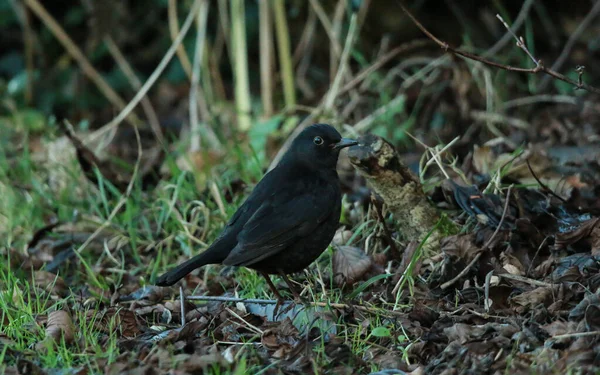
{"left": 156, "top": 124, "right": 358, "bottom": 300}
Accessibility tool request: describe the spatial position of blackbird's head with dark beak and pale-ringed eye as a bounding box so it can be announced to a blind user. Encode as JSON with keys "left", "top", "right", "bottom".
{"left": 285, "top": 124, "right": 358, "bottom": 169}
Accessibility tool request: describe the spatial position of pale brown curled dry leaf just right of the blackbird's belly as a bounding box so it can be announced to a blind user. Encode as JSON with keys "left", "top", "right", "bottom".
{"left": 333, "top": 246, "right": 373, "bottom": 286}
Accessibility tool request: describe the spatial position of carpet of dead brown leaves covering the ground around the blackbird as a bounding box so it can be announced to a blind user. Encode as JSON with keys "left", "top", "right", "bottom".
{"left": 2, "top": 120, "right": 600, "bottom": 374}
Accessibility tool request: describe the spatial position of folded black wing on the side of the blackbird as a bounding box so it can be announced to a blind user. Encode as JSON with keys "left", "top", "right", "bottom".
{"left": 223, "top": 185, "right": 339, "bottom": 266}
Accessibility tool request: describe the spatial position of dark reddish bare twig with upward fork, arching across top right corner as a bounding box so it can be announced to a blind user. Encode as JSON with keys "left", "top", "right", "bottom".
{"left": 400, "top": 4, "right": 600, "bottom": 94}
